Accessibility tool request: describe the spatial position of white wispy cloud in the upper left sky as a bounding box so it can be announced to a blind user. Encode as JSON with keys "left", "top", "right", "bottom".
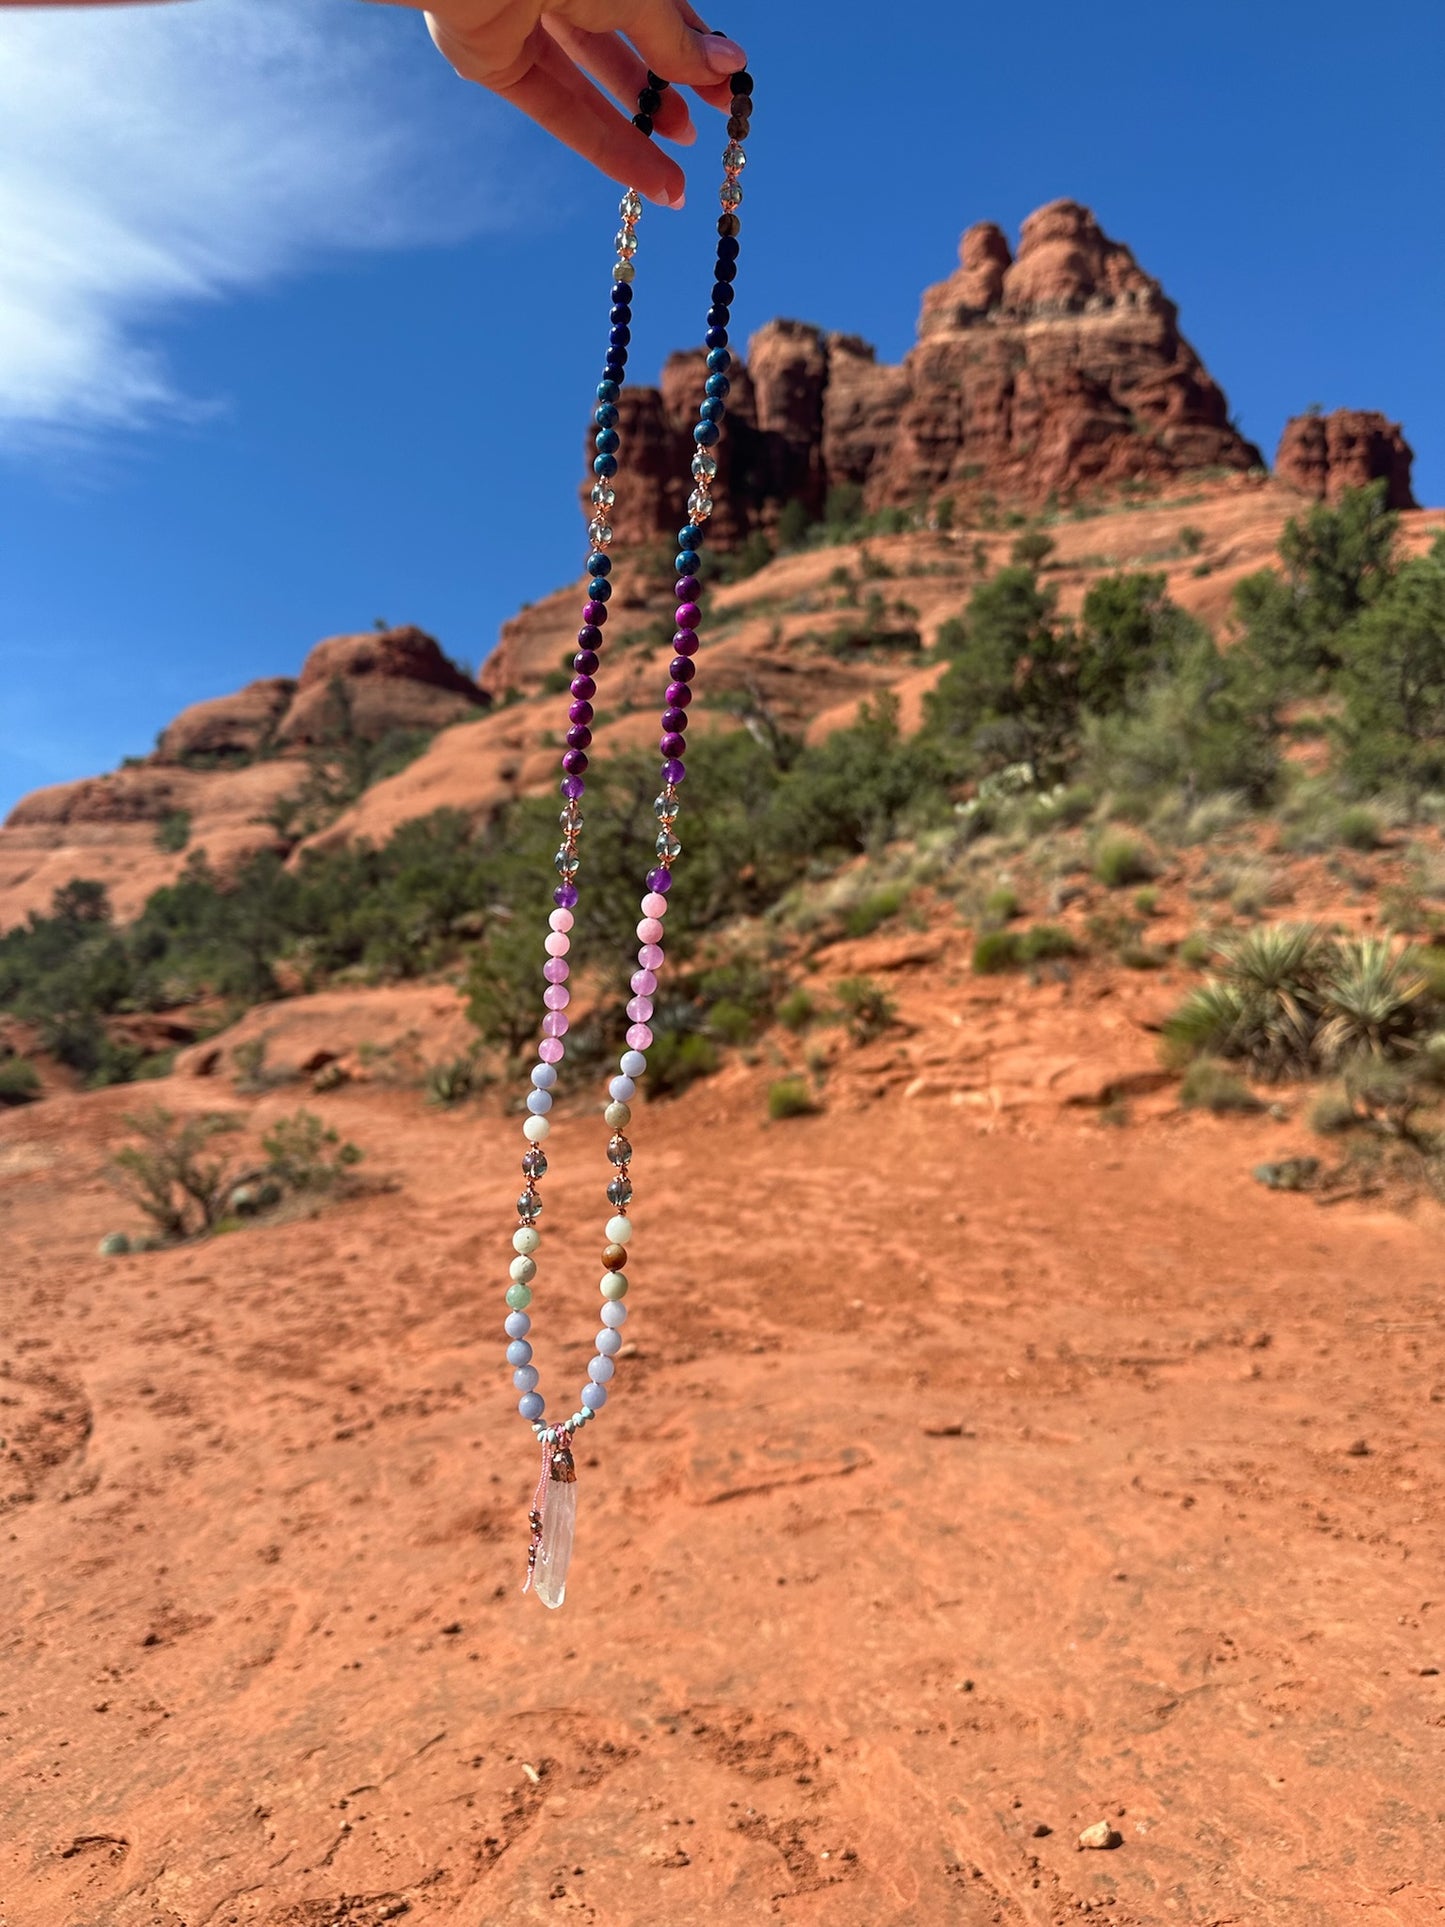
{"left": 0, "top": 0, "right": 507, "bottom": 451}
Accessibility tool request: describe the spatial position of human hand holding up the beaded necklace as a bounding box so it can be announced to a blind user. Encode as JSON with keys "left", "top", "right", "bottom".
{"left": 401, "top": 0, "right": 748, "bottom": 208}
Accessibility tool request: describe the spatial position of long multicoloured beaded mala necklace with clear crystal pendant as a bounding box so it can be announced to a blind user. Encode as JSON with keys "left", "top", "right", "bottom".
{"left": 505, "top": 60, "right": 753, "bottom": 1607}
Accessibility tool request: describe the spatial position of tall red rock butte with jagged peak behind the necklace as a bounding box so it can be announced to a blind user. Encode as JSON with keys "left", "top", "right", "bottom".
{"left": 601, "top": 200, "right": 1262, "bottom": 543}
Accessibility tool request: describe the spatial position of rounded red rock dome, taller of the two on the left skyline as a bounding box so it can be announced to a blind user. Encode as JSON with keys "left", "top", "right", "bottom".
{"left": 276, "top": 628, "right": 487, "bottom": 746}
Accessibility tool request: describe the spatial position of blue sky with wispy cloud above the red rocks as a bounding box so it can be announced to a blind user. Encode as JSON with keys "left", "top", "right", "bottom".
{"left": 0, "top": 0, "right": 1445, "bottom": 811}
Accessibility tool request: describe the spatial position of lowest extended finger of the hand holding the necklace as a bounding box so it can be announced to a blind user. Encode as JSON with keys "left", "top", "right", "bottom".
{"left": 428, "top": 17, "right": 684, "bottom": 208}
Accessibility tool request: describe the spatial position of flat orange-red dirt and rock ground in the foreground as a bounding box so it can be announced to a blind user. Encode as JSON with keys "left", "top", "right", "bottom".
{"left": 0, "top": 1048, "right": 1445, "bottom": 1927}
